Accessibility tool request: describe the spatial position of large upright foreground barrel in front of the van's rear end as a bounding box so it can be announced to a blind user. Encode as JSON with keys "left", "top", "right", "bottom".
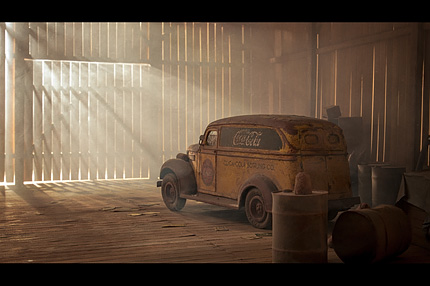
{"left": 272, "top": 191, "right": 328, "bottom": 263}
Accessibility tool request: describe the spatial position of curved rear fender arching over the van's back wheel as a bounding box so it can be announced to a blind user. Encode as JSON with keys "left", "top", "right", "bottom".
{"left": 239, "top": 174, "right": 278, "bottom": 212}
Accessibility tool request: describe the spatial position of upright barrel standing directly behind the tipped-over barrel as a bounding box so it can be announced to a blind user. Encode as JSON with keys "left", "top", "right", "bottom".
{"left": 372, "top": 166, "right": 406, "bottom": 206}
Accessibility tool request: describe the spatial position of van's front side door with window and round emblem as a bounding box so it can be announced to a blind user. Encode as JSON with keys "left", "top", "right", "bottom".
{"left": 197, "top": 129, "right": 218, "bottom": 193}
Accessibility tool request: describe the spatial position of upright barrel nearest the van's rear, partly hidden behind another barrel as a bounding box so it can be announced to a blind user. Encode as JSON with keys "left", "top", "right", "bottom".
{"left": 357, "top": 163, "right": 388, "bottom": 206}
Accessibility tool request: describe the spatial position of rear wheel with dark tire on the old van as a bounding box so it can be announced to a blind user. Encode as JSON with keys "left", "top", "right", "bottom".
{"left": 245, "top": 188, "right": 272, "bottom": 229}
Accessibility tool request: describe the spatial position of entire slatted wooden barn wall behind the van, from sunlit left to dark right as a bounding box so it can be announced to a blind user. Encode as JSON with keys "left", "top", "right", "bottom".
{"left": 0, "top": 22, "right": 430, "bottom": 184}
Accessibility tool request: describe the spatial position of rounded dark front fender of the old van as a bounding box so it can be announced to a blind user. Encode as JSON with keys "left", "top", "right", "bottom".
{"left": 160, "top": 158, "right": 197, "bottom": 195}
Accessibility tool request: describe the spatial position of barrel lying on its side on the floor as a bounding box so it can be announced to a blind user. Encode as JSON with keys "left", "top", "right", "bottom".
{"left": 332, "top": 205, "right": 412, "bottom": 263}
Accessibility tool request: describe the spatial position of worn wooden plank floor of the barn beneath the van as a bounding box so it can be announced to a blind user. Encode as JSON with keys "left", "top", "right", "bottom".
{"left": 0, "top": 180, "right": 430, "bottom": 263}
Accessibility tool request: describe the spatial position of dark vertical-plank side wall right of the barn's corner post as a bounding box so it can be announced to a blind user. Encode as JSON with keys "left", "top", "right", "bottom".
{"left": 315, "top": 23, "right": 428, "bottom": 170}
